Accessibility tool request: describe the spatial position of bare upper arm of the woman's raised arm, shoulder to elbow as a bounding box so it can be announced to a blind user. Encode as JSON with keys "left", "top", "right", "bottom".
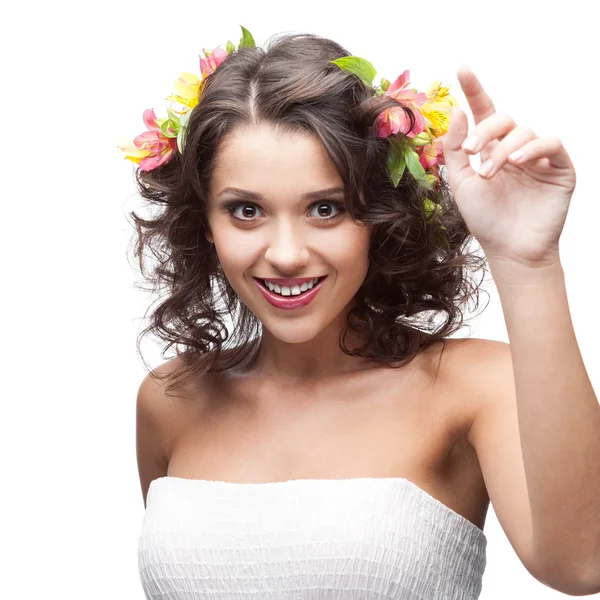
{"left": 462, "top": 339, "right": 548, "bottom": 585}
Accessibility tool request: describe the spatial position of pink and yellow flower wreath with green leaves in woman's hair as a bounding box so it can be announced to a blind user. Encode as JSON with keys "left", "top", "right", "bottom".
{"left": 118, "top": 26, "right": 458, "bottom": 248}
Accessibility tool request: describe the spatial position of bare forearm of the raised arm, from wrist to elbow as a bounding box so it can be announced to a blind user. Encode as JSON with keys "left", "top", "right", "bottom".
{"left": 490, "top": 258, "right": 600, "bottom": 578}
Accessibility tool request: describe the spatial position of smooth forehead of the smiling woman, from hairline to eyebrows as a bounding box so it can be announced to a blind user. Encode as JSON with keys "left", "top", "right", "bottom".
{"left": 211, "top": 124, "right": 342, "bottom": 195}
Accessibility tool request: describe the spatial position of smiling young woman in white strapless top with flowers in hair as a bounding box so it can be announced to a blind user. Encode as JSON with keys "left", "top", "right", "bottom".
{"left": 119, "top": 30, "right": 600, "bottom": 600}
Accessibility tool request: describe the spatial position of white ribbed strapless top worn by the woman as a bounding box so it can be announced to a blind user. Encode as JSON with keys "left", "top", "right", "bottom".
{"left": 138, "top": 477, "right": 487, "bottom": 600}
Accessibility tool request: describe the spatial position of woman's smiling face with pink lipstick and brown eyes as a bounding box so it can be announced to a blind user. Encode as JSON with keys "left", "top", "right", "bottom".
{"left": 206, "top": 125, "right": 370, "bottom": 343}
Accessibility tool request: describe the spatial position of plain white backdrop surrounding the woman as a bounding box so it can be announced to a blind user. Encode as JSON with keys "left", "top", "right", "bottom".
{"left": 0, "top": 0, "right": 600, "bottom": 600}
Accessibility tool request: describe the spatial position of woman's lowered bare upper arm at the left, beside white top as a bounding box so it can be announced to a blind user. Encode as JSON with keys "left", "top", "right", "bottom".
{"left": 136, "top": 374, "right": 170, "bottom": 508}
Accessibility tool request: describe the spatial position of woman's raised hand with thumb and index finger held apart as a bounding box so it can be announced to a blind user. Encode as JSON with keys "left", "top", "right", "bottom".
{"left": 443, "top": 67, "right": 576, "bottom": 267}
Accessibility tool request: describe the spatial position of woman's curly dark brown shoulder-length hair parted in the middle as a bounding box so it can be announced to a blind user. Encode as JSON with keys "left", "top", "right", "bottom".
{"left": 125, "top": 34, "right": 486, "bottom": 393}
